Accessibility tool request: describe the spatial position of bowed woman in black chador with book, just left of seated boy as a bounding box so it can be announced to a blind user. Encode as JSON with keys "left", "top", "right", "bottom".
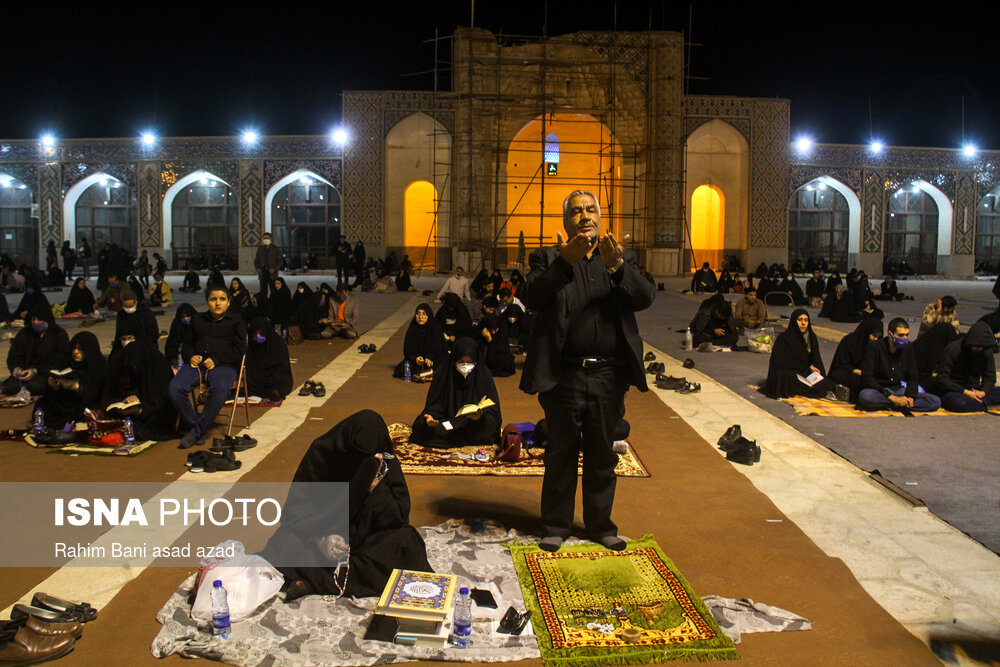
{"left": 103, "top": 340, "right": 177, "bottom": 440}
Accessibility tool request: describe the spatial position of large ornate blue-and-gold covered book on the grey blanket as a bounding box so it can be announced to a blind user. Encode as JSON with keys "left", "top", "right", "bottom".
{"left": 375, "top": 568, "right": 458, "bottom": 622}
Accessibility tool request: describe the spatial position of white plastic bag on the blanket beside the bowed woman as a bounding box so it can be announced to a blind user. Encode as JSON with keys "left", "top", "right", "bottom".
{"left": 191, "top": 540, "right": 285, "bottom": 623}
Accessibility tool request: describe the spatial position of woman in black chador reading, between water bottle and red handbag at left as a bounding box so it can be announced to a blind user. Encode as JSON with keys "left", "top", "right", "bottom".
{"left": 38, "top": 331, "right": 108, "bottom": 429}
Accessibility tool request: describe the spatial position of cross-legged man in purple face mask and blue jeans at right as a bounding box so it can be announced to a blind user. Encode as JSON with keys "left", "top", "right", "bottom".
{"left": 857, "top": 317, "right": 941, "bottom": 413}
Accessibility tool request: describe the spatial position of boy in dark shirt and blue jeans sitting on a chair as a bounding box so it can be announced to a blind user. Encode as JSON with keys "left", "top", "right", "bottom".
{"left": 170, "top": 285, "right": 247, "bottom": 449}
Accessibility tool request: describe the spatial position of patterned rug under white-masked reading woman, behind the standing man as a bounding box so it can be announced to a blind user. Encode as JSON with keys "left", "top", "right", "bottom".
{"left": 389, "top": 423, "right": 650, "bottom": 477}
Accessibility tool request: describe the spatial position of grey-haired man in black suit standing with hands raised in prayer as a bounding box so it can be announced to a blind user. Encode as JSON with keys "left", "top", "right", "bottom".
{"left": 518, "top": 190, "right": 656, "bottom": 551}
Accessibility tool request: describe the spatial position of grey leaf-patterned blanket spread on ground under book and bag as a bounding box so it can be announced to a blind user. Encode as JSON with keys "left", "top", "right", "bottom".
{"left": 150, "top": 520, "right": 812, "bottom": 667}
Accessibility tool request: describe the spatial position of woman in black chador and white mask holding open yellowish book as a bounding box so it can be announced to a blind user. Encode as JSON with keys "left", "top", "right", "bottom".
{"left": 410, "top": 338, "right": 503, "bottom": 447}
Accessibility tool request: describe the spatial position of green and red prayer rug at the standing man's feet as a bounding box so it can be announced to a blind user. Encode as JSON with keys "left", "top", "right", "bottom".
{"left": 507, "top": 535, "right": 740, "bottom": 667}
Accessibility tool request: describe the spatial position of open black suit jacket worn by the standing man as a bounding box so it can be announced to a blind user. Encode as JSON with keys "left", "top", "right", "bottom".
{"left": 517, "top": 247, "right": 656, "bottom": 394}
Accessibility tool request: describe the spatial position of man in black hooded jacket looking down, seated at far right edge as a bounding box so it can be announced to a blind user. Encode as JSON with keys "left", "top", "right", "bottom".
{"left": 930, "top": 320, "right": 1000, "bottom": 412}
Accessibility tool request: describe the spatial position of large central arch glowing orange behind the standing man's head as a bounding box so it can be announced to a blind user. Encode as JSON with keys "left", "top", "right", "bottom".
{"left": 497, "top": 112, "right": 623, "bottom": 251}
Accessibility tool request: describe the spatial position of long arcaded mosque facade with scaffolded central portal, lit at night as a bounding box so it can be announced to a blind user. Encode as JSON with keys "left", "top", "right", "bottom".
{"left": 0, "top": 28, "right": 1000, "bottom": 276}
